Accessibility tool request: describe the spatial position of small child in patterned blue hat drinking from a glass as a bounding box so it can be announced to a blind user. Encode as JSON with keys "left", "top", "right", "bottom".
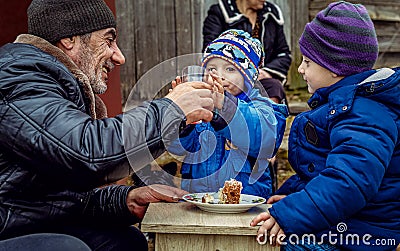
{"left": 168, "top": 30, "right": 287, "bottom": 198}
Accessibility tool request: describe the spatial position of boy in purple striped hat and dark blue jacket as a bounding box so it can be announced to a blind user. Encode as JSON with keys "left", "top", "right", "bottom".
{"left": 251, "top": 1, "right": 400, "bottom": 250}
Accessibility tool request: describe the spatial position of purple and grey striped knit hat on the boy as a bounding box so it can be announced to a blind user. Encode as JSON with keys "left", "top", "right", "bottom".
{"left": 299, "top": 1, "right": 378, "bottom": 76}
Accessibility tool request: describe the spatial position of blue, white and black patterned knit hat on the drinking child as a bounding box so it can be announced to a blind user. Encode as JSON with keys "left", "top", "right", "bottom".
{"left": 202, "top": 29, "right": 264, "bottom": 94}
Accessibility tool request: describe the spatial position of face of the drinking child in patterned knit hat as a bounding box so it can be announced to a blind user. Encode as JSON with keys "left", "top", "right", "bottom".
{"left": 206, "top": 58, "right": 245, "bottom": 96}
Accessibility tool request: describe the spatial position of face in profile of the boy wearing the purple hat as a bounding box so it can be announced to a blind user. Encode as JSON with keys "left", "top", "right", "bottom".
{"left": 297, "top": 56, "right": 343, "bottom": 93}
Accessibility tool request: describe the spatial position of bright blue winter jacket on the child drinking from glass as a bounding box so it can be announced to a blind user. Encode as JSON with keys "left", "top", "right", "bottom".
{"left": 168, "top": 88, "right": 288, "bottom": 198}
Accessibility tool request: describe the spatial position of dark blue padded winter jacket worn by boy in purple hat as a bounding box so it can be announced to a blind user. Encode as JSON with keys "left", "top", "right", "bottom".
{"left": 269, "top": 68, "right": 400, "bottom": 250}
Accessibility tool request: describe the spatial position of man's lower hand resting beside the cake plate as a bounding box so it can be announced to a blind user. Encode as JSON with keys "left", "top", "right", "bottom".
{"left": 126, "top": 184, "right": 188, "bottom": 219}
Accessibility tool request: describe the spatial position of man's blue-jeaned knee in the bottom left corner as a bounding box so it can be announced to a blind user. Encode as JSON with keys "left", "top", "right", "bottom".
{"left": 0, "top": 233, "right": 90, "bottom": 251}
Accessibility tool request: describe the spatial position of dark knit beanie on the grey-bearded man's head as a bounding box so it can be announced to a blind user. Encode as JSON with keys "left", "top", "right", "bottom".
{"left": 27, "top": 0, "right": 116, "bottom": 43}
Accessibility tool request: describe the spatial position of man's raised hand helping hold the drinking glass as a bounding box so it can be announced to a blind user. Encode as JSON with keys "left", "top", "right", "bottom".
{"left": 166, "top": 82, "right": 214, "bottom": 124}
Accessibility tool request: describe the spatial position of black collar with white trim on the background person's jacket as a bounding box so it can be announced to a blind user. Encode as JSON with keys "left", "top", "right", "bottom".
{"left": 218, "top": 0, "right": 284, "bottom": 25}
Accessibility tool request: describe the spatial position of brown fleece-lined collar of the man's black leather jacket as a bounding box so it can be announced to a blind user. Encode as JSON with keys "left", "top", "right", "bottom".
{"left": 14, "top": 34, "right": 107, "bottom": 119}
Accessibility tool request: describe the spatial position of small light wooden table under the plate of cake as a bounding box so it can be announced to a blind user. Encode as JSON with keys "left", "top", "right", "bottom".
{"left": 141, "top": 202, "right": 279, "bottom": 251}
